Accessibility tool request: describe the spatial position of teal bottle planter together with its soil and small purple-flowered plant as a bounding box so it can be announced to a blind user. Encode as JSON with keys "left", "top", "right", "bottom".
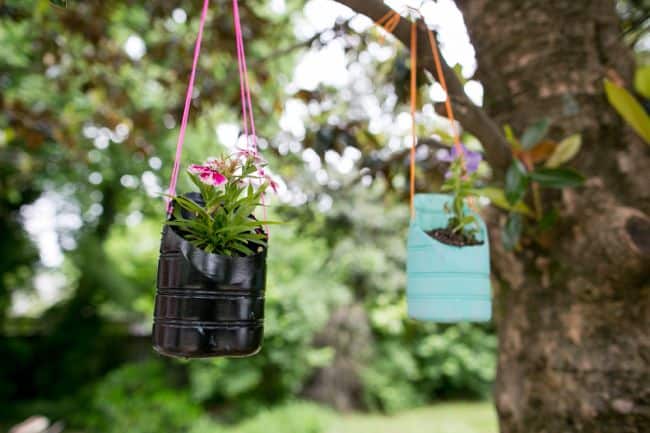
{"left": 407, "top": 146, "right": 491, "bottom": 322}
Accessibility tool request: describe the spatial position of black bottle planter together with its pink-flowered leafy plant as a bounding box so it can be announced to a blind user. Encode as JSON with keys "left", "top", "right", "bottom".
{"left": 153, "top": 151, "right": 276, "bottom": 358}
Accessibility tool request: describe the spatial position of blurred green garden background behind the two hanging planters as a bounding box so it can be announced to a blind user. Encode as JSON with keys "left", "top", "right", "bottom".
{"left": 0, "top": 0, "right": 524, "bottom": 433}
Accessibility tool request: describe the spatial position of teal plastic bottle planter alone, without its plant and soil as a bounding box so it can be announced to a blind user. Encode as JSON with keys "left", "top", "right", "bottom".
{"left": 406, "top": 194, "right": 492, "bottom": 322}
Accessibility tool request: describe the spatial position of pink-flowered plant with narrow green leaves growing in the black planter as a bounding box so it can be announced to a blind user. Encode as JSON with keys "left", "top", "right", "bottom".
{"left": 167, "top": 150, "right": 277, "bottom": 256}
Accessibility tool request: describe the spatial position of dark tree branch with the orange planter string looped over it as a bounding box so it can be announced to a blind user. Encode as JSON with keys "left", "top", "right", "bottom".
{"left": 335, "top": 0, "right": 511, "bottom": 177}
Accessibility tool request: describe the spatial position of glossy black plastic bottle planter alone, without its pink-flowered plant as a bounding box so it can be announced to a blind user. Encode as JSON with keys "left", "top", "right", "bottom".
{"left": 153, "top": 194, "right": 266, "bottom": 358}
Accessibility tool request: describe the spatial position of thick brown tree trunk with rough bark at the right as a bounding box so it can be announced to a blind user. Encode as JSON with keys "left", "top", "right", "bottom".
{"left": 457, "top": 0, "right": 650, "bottom": 433}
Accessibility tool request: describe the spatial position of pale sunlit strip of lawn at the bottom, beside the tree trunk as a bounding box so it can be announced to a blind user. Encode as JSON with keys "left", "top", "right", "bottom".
{"left": 327, "top": 402, "right": 498, "bottom": 433}
